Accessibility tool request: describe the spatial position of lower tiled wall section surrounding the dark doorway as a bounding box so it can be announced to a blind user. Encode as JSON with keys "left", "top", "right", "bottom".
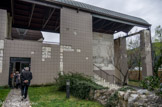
{"left": 0, "top": 40, "right": 60, "bottom": 85}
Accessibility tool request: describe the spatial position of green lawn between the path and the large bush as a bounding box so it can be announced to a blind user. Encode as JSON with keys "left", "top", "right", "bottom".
{"left": 29, "top": 85, "right": 103, "bottom": 107}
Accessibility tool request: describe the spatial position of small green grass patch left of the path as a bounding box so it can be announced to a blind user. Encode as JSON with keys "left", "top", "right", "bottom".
{"left": 0, "top": 87, "right": 10, "bottom": 107}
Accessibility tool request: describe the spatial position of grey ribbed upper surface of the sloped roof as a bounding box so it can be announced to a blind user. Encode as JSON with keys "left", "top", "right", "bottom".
{"left": 45, "top": 0, "right": 151, "bottom": 27}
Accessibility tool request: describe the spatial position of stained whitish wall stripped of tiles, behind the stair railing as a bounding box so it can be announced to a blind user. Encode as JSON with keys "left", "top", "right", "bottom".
{"left": 93, "top": 32, "right": 115, "bottom": 82}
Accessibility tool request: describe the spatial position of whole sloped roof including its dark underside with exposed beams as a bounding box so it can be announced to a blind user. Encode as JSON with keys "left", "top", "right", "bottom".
{"left": 0, "top": 0, "right": 151, "bottom": 34}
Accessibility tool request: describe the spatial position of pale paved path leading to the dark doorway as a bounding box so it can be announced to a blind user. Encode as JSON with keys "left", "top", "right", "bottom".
{"left": 2, "top": 89, "right": 31, "bottom": 107}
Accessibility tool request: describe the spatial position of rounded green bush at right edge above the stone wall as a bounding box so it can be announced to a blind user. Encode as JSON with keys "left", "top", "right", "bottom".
{"left": 140, "top": 76, "right": 160, "bottom": 91}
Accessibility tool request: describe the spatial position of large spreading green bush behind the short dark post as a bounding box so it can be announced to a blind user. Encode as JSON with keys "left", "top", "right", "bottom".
{"left": 56, "top": 73, "right": 104, "bottom": 99}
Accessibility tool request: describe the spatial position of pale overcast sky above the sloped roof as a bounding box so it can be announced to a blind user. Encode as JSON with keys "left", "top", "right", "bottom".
{"left": 42, "top": 0, "right": 162, "bottom": 42}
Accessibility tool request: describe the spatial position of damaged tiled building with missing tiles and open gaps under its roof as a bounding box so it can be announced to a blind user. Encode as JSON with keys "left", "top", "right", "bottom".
{"left": 0, "top": 0, "right": 152, "bottom": 86}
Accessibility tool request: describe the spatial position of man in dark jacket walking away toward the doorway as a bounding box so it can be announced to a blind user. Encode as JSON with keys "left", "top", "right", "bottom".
{"left": 20, "top": 67, "right": 32, "bottom": 100}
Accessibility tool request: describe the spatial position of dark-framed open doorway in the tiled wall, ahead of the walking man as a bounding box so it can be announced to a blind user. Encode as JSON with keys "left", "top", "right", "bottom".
{"left": 8, "top": 57, "right": 31, "bottom": 87}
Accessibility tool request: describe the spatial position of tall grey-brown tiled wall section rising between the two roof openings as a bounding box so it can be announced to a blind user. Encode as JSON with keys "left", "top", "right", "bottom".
{"left": 60, "top": 8, "right": 93, "bottom": 75}
